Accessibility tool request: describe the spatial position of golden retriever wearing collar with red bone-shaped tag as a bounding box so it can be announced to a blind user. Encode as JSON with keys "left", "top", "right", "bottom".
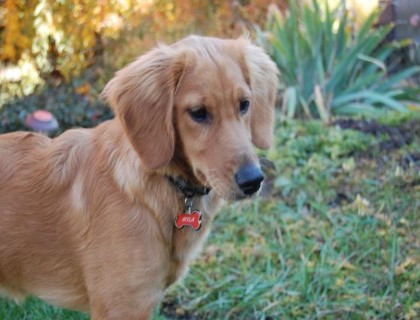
{"left": 0, "top": 36, "right": 278, "bottom": 320}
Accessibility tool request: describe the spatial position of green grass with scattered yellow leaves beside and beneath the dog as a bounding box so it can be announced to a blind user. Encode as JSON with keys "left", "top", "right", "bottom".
{"left": 0, "top": 114, "right": 420, "bottom": 320}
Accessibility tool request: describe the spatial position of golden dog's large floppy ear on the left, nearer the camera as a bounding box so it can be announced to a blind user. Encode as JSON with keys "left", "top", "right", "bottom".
{"left": 101, "top": 46, "right": 184, "bottom": 170}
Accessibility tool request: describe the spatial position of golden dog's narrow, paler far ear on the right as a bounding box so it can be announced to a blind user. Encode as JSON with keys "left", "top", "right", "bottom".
{"left": 245, "top": 43, "right": 278, "bottom": 149}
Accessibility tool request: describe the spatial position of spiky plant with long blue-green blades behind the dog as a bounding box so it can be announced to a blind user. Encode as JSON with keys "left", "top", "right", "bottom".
{"left": 257, "top": 0, "right": 420, "bottom": 121}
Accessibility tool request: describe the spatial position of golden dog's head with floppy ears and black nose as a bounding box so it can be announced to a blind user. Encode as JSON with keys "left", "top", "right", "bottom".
{"left": 103, "top": 36, "right": 277, "bottom": 199}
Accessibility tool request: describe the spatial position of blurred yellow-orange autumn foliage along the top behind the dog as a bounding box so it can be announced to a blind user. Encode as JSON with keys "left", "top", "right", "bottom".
{"left": 0, "top": 0, "right": 286, "bottom": 78}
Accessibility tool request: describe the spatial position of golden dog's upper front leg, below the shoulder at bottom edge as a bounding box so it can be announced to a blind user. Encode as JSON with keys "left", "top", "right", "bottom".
{"left": 83, "top": 205, "right": 169, "bottom": 320}
